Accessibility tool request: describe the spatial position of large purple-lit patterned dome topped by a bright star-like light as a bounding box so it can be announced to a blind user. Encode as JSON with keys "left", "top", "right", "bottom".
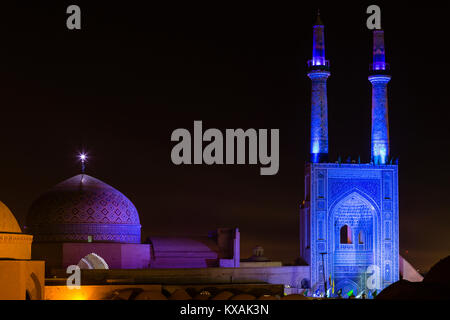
{"left": 27, "top": 174, "right": 141, "bottom": 243}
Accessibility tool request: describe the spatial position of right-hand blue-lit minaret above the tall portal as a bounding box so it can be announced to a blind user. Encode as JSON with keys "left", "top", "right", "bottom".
{"left": 369, "top": 30, "right": 391, "bottom": 164}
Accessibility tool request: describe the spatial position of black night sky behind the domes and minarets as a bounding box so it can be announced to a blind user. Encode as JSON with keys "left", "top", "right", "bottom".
{"left": 0, "top": 1, "right": 450, "bottom": 271}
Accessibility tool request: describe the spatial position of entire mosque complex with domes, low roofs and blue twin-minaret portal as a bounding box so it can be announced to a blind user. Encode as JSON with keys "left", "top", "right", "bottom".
{"left": 0, "top": 16, "right": 422, "bottom": 299}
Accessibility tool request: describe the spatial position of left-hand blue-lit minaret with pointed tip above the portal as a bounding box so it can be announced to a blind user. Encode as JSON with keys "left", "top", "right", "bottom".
{"left": 308, "top": 14, "right": 330, "bottom": 163}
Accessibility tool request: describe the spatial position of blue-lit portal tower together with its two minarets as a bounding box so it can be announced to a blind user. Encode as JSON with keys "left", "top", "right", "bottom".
{"left": 300, "top": 14, "right": 399, "bottom": 294}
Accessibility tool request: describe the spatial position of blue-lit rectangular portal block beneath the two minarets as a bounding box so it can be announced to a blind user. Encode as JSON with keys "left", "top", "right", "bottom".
{"left": 300, "top": 163, "right": 399, "bottom": 295}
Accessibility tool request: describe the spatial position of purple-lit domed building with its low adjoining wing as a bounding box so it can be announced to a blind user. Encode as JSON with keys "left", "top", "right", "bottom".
{"left": 27, "top": 174, "right": 240, "bottom": 276}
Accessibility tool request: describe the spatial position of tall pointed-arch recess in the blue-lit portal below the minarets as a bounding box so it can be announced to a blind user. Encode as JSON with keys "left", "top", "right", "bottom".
{"left": 326, "top": 190, "right": 380, "bottom": 296}
